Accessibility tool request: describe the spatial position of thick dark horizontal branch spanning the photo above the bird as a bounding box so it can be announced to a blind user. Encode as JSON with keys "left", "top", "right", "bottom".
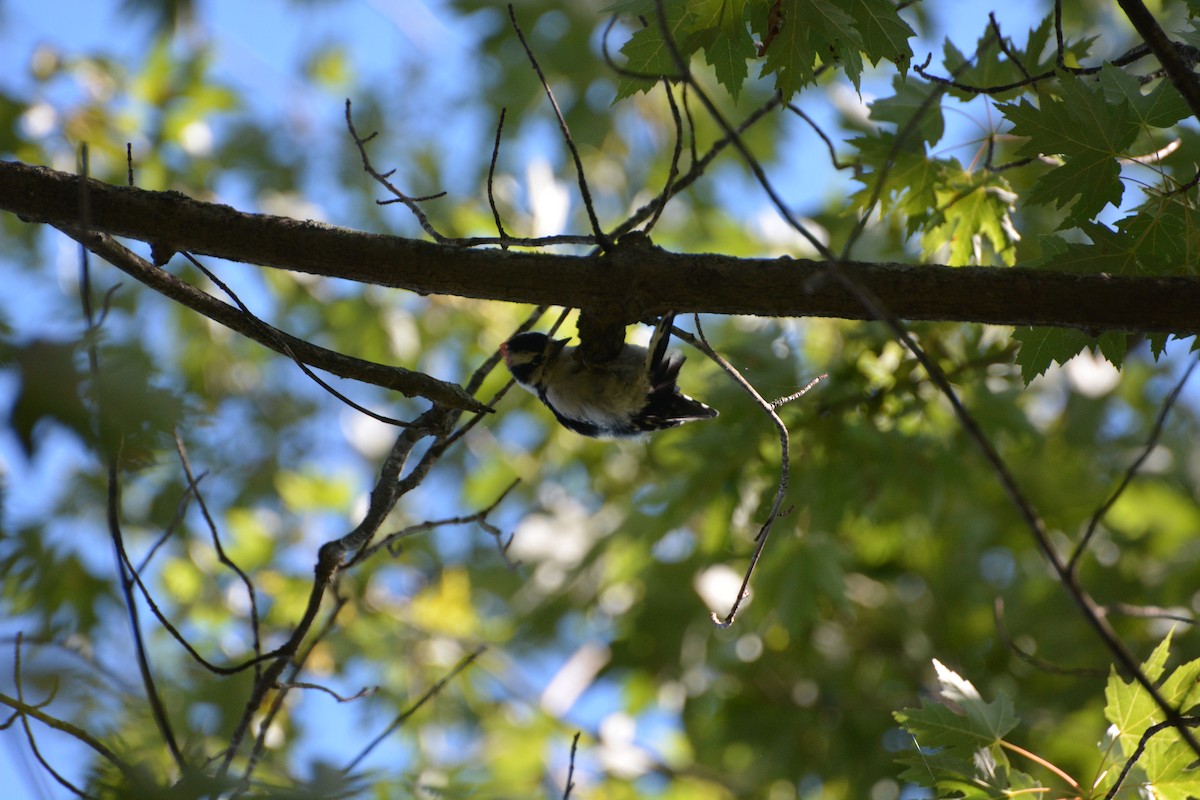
{"left": 0, "top": 161, "right": 1200, "bottom": 333}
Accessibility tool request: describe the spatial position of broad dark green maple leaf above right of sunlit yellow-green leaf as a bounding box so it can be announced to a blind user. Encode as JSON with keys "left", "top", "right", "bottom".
{"left": 1000, "top": 76, "right": 1139, "bottom": 227}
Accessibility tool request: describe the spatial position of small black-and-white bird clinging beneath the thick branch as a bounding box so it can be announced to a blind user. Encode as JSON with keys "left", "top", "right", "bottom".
{"left": 500, "top": 313, "right": 716, "bottom": 439}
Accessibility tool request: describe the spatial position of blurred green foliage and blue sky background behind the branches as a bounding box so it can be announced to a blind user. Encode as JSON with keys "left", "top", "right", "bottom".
{"left": 0, "top": 0, "right": 1200, "bottom": 800}
